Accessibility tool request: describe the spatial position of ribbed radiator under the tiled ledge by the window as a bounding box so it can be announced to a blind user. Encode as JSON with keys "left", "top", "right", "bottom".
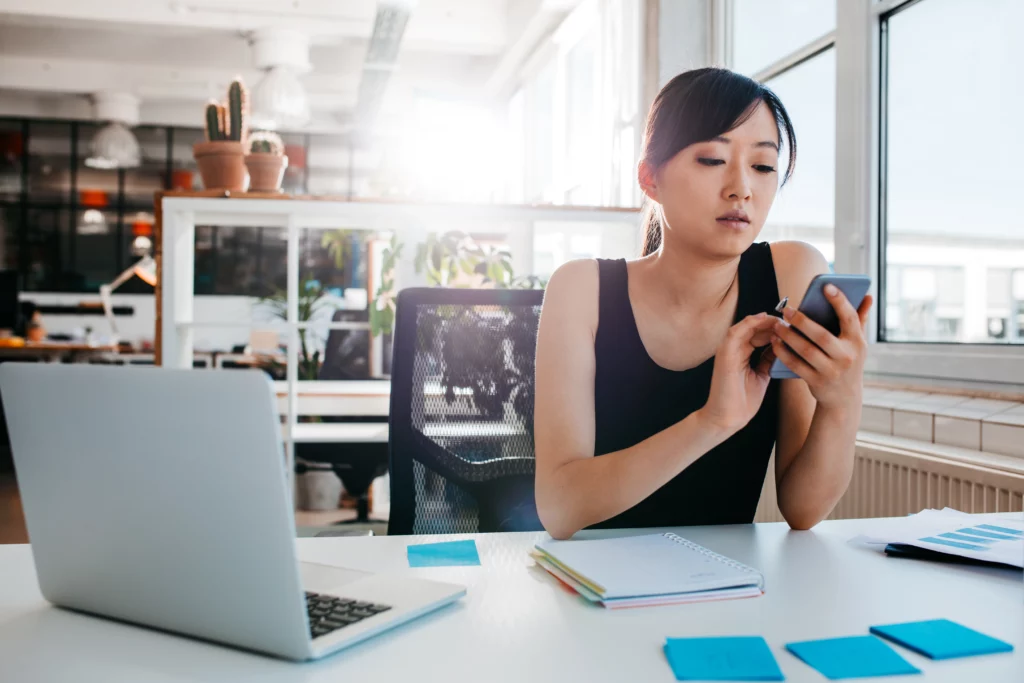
{"left": 754, "top": 441, "right": 1024, "bottom": 522}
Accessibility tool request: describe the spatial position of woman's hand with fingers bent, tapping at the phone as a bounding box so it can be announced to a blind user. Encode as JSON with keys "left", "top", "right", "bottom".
{"left": 698, "top": 313, "right": 775, "bottom": 438}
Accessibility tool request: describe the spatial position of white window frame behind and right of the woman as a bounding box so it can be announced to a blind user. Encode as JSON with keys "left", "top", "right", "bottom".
{"left": 711, "top": 0, "right": 1024, "bottom": 390}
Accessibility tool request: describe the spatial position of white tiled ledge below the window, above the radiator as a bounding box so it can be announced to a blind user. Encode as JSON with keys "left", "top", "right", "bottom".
{"left": 860, "top": 387, "right": 1024, "bottom": 458}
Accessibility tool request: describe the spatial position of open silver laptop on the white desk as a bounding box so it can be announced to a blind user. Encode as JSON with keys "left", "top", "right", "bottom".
{"left": 0, "top": 362, "right": 466, "bottom": 659}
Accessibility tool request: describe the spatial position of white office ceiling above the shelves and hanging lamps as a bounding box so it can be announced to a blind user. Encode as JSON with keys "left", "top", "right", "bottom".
{"left": 0, "top": 0, "right": 580, "bottom": 132}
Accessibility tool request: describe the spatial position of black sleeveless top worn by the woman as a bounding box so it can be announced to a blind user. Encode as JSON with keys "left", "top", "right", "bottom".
{"left": 594, "top": 243, "right": 778, "bottom": 528}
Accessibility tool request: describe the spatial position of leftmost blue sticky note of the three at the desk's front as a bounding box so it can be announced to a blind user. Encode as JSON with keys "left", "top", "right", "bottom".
{"left": 665, "top": 636, "right": 785, "bottom": 681}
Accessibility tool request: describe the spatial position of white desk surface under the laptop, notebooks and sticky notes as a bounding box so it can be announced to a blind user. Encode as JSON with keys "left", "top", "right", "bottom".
{"left": 0, "top": 520, "right": 1024, "bottom": 683}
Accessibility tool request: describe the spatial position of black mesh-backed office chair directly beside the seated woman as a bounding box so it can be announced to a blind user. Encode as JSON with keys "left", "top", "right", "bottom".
{"left": 388, "top": 289, "right": 544, "bottom": 533}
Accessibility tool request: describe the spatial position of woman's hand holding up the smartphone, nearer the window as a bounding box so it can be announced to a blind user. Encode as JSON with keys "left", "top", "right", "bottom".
{"left": 772, "top": 285, "right": 872, "bottom": 407}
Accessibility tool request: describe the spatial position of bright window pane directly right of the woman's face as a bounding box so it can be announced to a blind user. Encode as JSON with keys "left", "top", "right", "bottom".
{"left": 760, "top": 48, "right": 836, "bottom": 263}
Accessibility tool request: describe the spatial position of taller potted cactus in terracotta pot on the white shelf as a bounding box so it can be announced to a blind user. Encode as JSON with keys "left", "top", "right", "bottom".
{"left": 193, "top": 79, "right": 249, "bottom": 191}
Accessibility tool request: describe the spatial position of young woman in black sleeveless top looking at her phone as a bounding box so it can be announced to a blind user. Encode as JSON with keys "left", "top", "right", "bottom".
{"left": 535, "top": 69, "right": 871, "bottom": 539}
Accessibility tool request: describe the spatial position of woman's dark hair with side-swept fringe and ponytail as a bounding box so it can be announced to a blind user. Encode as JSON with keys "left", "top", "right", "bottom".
{"left": 640, "top": 68, "right": 797, "bottom": 256}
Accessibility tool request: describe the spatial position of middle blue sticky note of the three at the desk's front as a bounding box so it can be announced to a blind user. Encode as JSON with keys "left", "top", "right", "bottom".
{"left": 785, "top": 636, "right": 921, "bottom": 681}
